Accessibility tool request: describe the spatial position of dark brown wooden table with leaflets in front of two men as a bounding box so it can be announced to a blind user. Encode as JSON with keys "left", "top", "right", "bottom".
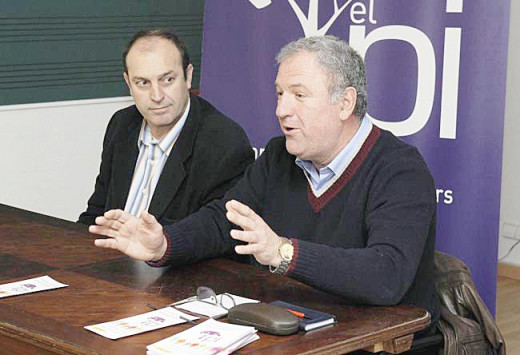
{"left": 0, "top": 204, "right": 430, "bottom": 355}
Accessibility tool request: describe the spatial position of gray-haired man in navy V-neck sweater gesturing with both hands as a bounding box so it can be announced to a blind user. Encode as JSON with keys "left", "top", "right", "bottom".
{"left": 90, "top": 36, "right": 439, "bottom": 322}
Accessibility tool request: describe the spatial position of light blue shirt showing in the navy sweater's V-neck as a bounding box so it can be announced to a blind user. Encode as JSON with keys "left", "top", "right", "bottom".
{"left": 295, "top": 116, "right": 372, "bottom": 196}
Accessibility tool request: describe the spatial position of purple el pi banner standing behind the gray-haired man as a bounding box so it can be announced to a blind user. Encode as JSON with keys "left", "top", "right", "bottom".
{"left": 201, "top": 0, "right": 510, "bottom": 313}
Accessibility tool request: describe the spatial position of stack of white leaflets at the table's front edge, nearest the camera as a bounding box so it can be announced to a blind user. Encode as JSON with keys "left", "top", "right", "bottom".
{"left": 146, "top": 319, "right": 260, "bottom": 355}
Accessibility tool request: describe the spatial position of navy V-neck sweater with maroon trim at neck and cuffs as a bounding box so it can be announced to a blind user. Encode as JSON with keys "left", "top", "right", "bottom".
{"left": 158, "top": 126, "right": 438, "bottom": 321}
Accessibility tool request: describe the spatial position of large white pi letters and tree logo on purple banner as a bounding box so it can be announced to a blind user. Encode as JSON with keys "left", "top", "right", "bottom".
{"left": 249, "top": 0, "right": 462, "bottom": 139}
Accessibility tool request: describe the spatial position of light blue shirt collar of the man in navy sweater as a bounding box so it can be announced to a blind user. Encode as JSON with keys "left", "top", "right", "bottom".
{"left": 295, "top": 116, "right": 372, "bottom": 176}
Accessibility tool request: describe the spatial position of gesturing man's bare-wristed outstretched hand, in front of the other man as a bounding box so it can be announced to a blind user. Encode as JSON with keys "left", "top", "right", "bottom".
{"left": 88, "top": 210, "right": 167, "bottom": 261}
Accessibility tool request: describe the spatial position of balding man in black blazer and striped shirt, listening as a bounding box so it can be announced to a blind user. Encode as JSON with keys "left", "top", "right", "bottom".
{"left": 78, "top": 30, "right": 254, "bottom": 224}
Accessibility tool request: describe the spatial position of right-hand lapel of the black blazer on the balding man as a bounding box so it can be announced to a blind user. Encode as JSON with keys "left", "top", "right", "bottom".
{"left": 148, "top": 95, "right": 201, "bottom": 219}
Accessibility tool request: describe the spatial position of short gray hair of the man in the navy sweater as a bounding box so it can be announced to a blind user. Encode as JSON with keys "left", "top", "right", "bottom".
{"left": 276, "top": 35, "right": 367, "bottom": 118}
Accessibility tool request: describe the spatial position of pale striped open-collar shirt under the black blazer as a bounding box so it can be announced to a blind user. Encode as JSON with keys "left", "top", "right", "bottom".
{"left": 125, "top": 101, "right": 190, "bottom": 217}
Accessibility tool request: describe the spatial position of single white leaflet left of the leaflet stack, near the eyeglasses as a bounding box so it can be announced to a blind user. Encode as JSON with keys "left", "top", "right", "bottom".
{"left": 85, "top": 307, "right": 198, "bottom": 339}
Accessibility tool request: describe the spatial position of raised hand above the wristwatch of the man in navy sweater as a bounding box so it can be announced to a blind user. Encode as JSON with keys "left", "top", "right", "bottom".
{"left": 226, "top": 200, "right": 282, "bottom": 266}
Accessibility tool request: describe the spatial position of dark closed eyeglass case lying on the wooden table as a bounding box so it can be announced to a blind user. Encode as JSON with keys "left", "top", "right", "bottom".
{"left": 228, "top": 303, "right": 300, "bottom": 335}
